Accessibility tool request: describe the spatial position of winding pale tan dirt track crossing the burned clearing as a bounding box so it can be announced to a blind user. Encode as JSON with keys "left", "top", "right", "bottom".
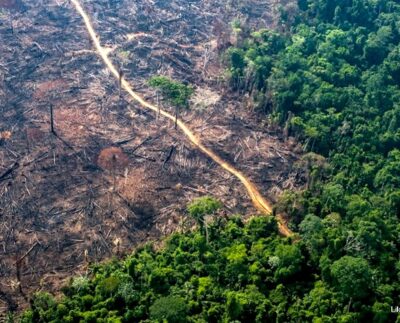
{"left": 71, "top": 0, "right": 293, "bottom": 237}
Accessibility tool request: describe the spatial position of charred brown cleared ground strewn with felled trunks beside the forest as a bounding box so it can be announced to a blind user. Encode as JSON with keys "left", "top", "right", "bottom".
{"left": 0, "top": 0, "right": 302, "bottom": 312}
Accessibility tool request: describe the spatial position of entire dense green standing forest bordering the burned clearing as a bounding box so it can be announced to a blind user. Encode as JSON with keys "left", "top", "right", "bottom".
{"left": 22, "top": 0, "right": 400, "bottom": 322}
